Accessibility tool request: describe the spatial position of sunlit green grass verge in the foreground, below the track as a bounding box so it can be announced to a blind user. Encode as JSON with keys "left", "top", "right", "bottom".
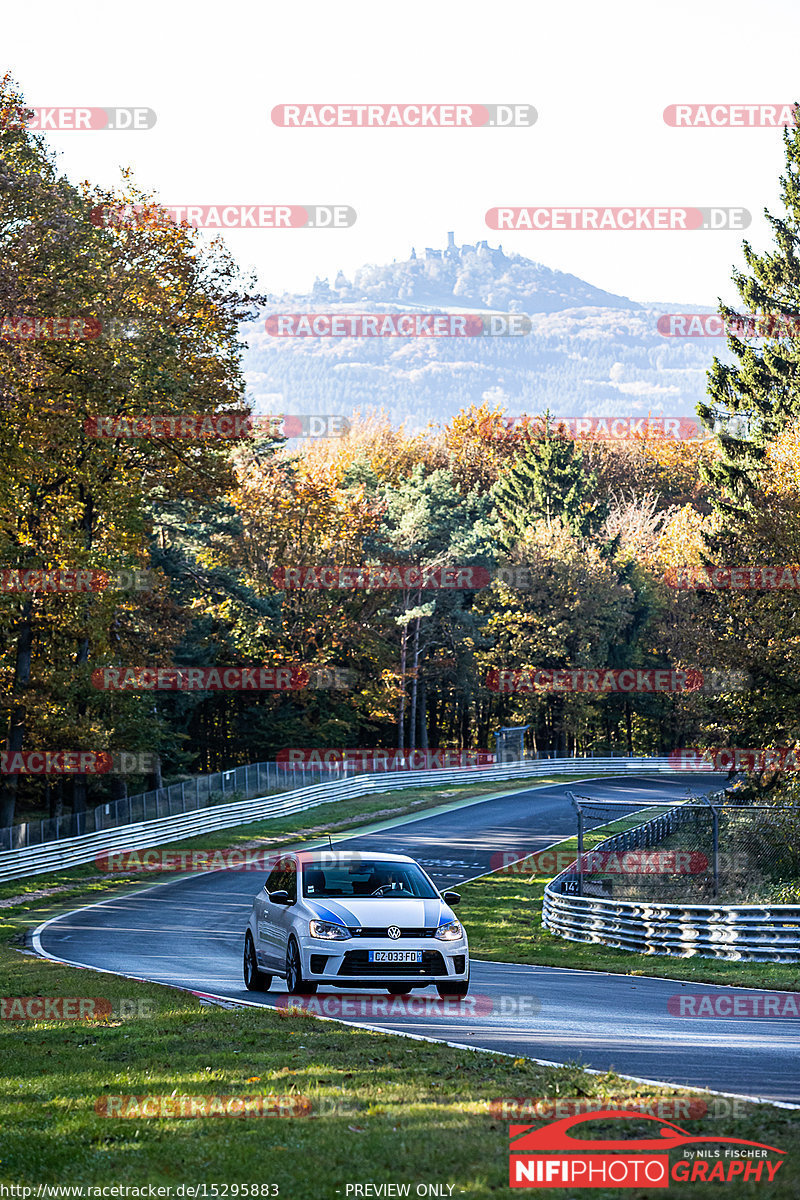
{"left": 0, "top": 944, "right": 800, "bottom": 1200}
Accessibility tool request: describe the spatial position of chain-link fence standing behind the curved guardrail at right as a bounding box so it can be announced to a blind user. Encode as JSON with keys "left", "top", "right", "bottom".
{"left": 561, "top": 793, "right": 800, "bottom": 904}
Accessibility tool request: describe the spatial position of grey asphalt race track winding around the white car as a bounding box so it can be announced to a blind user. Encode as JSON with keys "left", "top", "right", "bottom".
{"left": 35, "top": 775, "right": 800, "bottom": 1104}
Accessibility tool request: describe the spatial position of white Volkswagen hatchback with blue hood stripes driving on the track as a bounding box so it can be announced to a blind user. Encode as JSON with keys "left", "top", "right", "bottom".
{"left": 243, "top": 850, "right": 469, "bottom": 996}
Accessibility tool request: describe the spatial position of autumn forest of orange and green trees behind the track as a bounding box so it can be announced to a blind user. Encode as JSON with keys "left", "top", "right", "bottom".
{"left": 0, "top": 70, "right": 800, "bottom": 826}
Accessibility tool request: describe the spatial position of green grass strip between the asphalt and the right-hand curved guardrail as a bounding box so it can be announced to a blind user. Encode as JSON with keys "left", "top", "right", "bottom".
{"left": 458, "top": 830, "right": 800, "bottom": 991}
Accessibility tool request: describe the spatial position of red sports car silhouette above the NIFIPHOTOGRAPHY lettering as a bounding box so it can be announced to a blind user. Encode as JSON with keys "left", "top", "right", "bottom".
{"left": 509, "top": 1109, "right": 786, "bottom": 1154}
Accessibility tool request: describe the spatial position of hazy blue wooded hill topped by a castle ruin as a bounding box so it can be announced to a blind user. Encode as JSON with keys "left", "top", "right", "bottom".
{"left": 242, "top": 235, "right": 726, "bottom": 428}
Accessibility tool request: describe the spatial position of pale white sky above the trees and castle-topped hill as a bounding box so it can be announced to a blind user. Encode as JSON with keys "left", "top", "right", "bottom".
{"left": 0, "top": 0, "right": 800, "bottom": 305}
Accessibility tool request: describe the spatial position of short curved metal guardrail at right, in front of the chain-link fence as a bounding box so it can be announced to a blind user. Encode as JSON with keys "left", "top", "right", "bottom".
{"left": 542, "top": 805, "right": 800, "bottom": 962}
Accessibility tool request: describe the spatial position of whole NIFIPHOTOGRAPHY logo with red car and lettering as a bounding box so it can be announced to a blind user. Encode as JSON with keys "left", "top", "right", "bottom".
{"left": 509, "top": 1109, "right": 786, "bottom": 1188}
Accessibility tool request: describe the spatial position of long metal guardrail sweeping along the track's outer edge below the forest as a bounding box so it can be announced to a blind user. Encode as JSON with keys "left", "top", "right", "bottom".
{"left": 0, "top": 758, "right": 695, "bottom": 883}
